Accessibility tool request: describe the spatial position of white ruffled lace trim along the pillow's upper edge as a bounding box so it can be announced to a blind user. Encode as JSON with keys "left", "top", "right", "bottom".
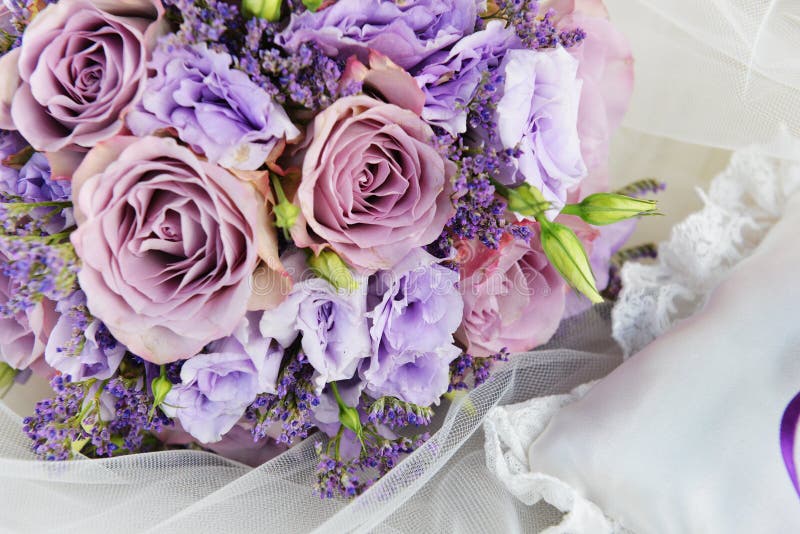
{"left": 612, "top": 149, "right": 800, "bottom": 357}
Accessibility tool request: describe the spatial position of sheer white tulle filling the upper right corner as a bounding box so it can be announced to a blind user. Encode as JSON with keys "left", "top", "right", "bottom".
{"left": 608, "top": 0, "right": 800, "bottom": 159}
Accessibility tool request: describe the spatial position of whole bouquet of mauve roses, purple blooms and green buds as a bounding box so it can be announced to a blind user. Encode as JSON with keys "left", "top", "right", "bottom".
{"left": 0, "top": 0, "right": 657, "bottom": 497}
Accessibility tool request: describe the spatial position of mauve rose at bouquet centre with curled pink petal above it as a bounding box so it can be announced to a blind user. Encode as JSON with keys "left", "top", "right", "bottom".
{"left": 293, "top": 54, "right": 456, "bottom": 271}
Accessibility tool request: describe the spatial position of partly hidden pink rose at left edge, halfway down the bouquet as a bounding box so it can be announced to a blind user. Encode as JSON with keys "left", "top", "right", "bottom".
{"left": 0, "top": 251, "right": 58, "bottom": 369}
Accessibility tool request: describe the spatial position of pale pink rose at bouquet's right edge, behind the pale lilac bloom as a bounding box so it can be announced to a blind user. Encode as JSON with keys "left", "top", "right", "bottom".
{"left": 553, "top": 0, "right": 633, "bottom": 202}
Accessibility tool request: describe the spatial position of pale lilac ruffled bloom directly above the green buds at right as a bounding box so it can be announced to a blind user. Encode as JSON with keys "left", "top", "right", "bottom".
{"left": 490, "top": 48, "right": 586, "bottom": 213}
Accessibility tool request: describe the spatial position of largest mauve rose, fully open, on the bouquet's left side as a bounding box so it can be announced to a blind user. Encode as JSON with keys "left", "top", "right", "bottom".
{"left": 72, "top": 137, "right": 262, "bottom": 363}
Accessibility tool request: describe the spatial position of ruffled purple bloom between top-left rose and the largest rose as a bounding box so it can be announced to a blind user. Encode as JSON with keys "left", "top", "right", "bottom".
{"left": 126, "top": 45, "right": 300, "bottom": 174}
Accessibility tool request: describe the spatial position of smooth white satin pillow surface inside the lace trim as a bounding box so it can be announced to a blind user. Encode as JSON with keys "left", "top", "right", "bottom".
{"left": 528, "top": 195, "right": 800, "bottom": 534}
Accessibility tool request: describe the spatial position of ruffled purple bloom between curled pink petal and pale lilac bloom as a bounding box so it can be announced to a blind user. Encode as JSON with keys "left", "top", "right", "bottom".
{"left": 415, "top": 20, "right": 522, "bottom": 134}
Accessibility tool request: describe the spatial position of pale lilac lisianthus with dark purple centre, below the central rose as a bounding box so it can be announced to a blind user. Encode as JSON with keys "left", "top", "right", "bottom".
{"left": 261, "top": 266, "right": 370, "bottom": 392}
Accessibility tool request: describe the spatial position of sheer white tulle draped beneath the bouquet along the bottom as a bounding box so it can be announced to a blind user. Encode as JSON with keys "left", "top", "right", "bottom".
{"left": 0, "top": 307, "right": 622, "bottom": 534}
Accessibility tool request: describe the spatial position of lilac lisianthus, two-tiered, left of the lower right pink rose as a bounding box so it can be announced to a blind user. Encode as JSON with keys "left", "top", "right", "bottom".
{"left": 360, "top": 249, "right": 464, "bottom": 406}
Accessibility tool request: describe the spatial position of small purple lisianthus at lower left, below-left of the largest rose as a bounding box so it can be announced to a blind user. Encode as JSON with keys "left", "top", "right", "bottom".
{"left": 44, "top": 290, "right": 126, "bottom": 382}
